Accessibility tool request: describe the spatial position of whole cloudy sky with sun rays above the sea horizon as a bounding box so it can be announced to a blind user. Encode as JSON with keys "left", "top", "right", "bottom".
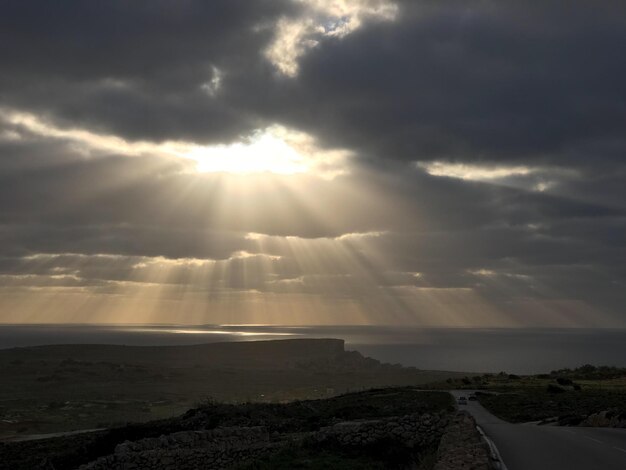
{"left": 0, "top": 0, "right": 626, "bottom": 328}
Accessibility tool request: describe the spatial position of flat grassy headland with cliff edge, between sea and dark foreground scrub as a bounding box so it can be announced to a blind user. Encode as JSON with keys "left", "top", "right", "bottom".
{"left": 0, "top": 340, "right": 464, "bottom": 439}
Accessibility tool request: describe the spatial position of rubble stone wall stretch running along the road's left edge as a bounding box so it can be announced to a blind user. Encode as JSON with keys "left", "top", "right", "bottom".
{"left": 434, "top": 411, "right": 496, "bottom": 470}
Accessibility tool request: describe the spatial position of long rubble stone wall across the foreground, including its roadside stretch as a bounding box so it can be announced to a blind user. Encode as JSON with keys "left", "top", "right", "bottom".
{"left": 79, "top": 412, "right": 494, "bottom": 470}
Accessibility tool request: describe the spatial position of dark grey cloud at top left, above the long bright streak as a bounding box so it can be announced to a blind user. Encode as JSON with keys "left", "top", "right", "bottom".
{"left": 0, "top": 0, "right": 296, "bottom": 141}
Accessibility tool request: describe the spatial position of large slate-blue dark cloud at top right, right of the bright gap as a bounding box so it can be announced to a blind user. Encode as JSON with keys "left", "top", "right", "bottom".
{"left": 276, "top": 1, "right": 626, "bottom": 165}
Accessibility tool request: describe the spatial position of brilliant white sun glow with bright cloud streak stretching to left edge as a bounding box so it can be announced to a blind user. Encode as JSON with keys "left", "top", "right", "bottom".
{"left": 0, "top": 108, "right": 352, "bottom": 179}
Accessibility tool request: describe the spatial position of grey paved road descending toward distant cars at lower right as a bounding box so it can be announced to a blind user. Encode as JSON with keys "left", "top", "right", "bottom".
{"left": 452, "top": 391, "right": 626, "bottom": 470}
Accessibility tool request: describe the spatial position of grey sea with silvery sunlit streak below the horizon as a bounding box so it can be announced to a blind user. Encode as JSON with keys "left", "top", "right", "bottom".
{"left": 0, "top": 324, "right": 626, "bottom": 374}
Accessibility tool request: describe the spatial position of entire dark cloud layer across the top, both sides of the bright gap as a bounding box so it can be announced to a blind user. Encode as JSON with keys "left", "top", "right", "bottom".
{"left": 0, "top": 1, "right": 626, "bottom": 166}
